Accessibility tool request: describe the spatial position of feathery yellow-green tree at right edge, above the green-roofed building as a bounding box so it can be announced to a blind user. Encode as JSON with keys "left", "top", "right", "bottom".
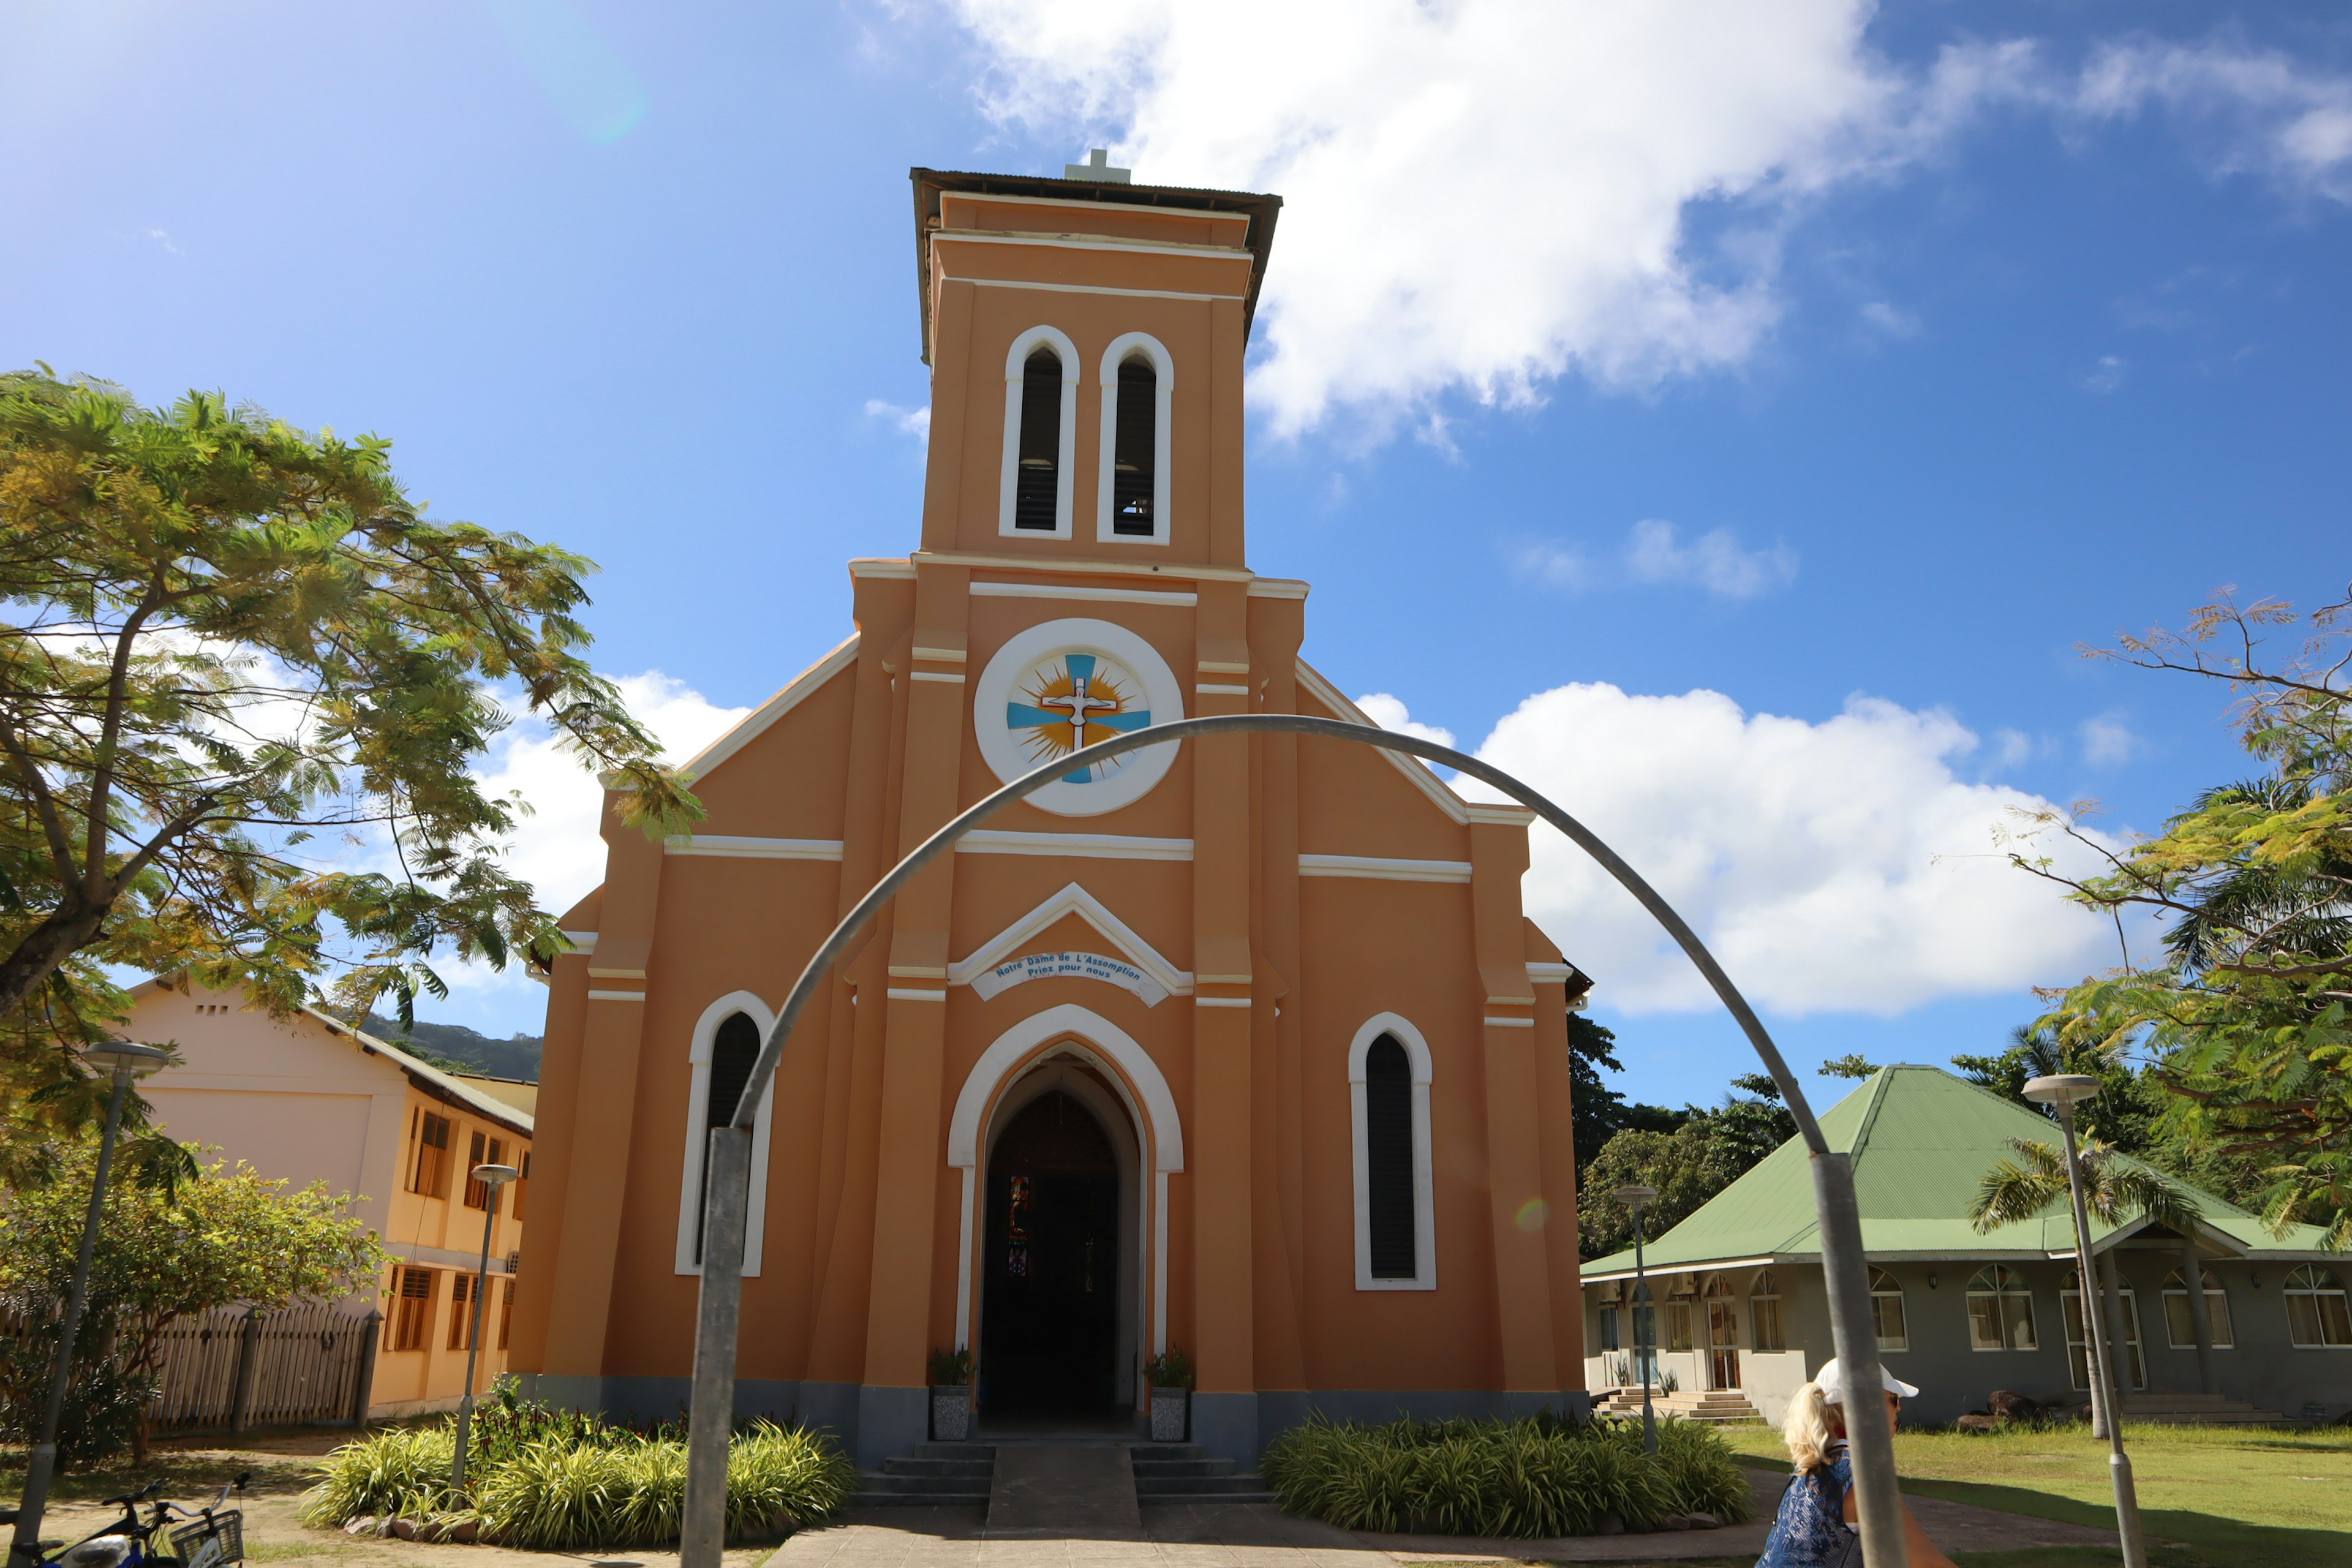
{"left": 2013, "top": 595, "right": 2352, "bottom": 1248}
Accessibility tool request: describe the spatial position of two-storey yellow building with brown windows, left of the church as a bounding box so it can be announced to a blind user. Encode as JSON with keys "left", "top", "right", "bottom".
{"left": 129, "top": 978, "right": 537, "bottom": 1417}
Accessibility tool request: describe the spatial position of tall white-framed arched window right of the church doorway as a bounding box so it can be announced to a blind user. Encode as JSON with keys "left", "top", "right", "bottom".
{"left": 1348, "top": 1013, "right": 1437, "bottom": 1291}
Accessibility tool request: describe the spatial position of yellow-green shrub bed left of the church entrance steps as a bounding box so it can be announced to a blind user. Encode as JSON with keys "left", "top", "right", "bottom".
{"left": 301, "top": 1389, "right": 859, "bottom": 1551}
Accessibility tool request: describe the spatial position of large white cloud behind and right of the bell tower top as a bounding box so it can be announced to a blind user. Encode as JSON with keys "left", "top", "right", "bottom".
{"left": 943, "top": 10, "right": 2352, "bottom": 435}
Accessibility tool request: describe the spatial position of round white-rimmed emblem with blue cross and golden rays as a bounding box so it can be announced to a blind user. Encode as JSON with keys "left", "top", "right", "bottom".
{"left": 971, "top": 620, "right": 1183, "bottom": 816}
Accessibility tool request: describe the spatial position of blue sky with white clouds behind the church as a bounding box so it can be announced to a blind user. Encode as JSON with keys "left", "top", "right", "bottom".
{"left": 0, "top": 0, "right": 2352, "bottom": 1100}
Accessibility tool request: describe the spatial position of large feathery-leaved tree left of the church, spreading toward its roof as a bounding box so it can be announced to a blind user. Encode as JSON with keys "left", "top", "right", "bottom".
{"left": 0, "top": 369, "right": 701, "bottom": 1112}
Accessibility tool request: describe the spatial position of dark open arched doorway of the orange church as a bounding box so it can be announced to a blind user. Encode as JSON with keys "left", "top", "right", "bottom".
{"left": 981, "top": 1088, "right": 1120, "bottom": 1415}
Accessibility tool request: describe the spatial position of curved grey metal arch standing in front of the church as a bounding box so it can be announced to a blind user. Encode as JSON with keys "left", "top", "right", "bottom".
{"left": 682, "top": 712, "right": 1910, "bottom": 1568}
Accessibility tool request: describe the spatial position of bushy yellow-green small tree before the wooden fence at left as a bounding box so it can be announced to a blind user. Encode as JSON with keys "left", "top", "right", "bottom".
{"left": 0, "top": 1138, "right": 386, "bottom": 1462}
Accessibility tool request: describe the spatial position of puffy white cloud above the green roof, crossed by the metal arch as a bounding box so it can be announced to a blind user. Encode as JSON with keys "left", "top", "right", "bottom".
{"left": 1477, "top": 684, "right": 2114, "bottom": 1013}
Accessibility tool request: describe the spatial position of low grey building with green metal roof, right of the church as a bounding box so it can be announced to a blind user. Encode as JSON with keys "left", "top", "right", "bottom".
{"left": 1583, "top": 1067, "right": 2352, "bottom": 1422}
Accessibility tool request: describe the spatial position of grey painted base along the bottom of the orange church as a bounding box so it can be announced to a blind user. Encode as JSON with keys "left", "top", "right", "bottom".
{"left": 520, "top": 1373, "right": 1593, "bottom": 1469}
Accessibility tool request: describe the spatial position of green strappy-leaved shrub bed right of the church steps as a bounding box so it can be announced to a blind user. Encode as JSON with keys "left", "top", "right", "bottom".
{"left": 1258, "top": 1415, "right": 1747, "bottom": 1540}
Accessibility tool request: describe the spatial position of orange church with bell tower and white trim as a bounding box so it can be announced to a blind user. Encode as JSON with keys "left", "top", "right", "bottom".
{"left": 513, "top": 162, "right": 1585, "bottom": 1467}
